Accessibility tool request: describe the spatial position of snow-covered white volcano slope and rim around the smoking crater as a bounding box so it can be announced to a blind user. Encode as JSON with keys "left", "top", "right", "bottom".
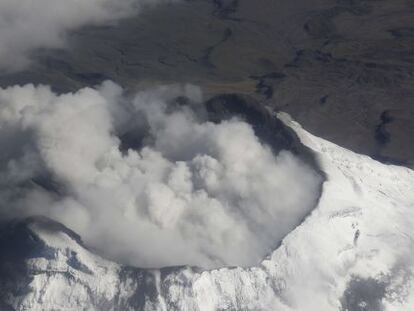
{"left": 0, "top": 114, "right": 414, "bottom": 311}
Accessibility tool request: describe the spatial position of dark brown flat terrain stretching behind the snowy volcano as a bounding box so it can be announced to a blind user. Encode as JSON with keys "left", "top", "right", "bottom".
{"left": 0, "top": 0, "right": 414, "bottom": 168}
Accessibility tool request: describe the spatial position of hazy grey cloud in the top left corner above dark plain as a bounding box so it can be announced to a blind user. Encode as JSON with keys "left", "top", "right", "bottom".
{"left": 0, "top": 0, "right": 163, "bottom": 70}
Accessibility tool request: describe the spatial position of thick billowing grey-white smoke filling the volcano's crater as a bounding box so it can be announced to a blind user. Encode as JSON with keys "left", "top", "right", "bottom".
{"left": 0, "top": 82, "right": 320, "bottom": 267}
